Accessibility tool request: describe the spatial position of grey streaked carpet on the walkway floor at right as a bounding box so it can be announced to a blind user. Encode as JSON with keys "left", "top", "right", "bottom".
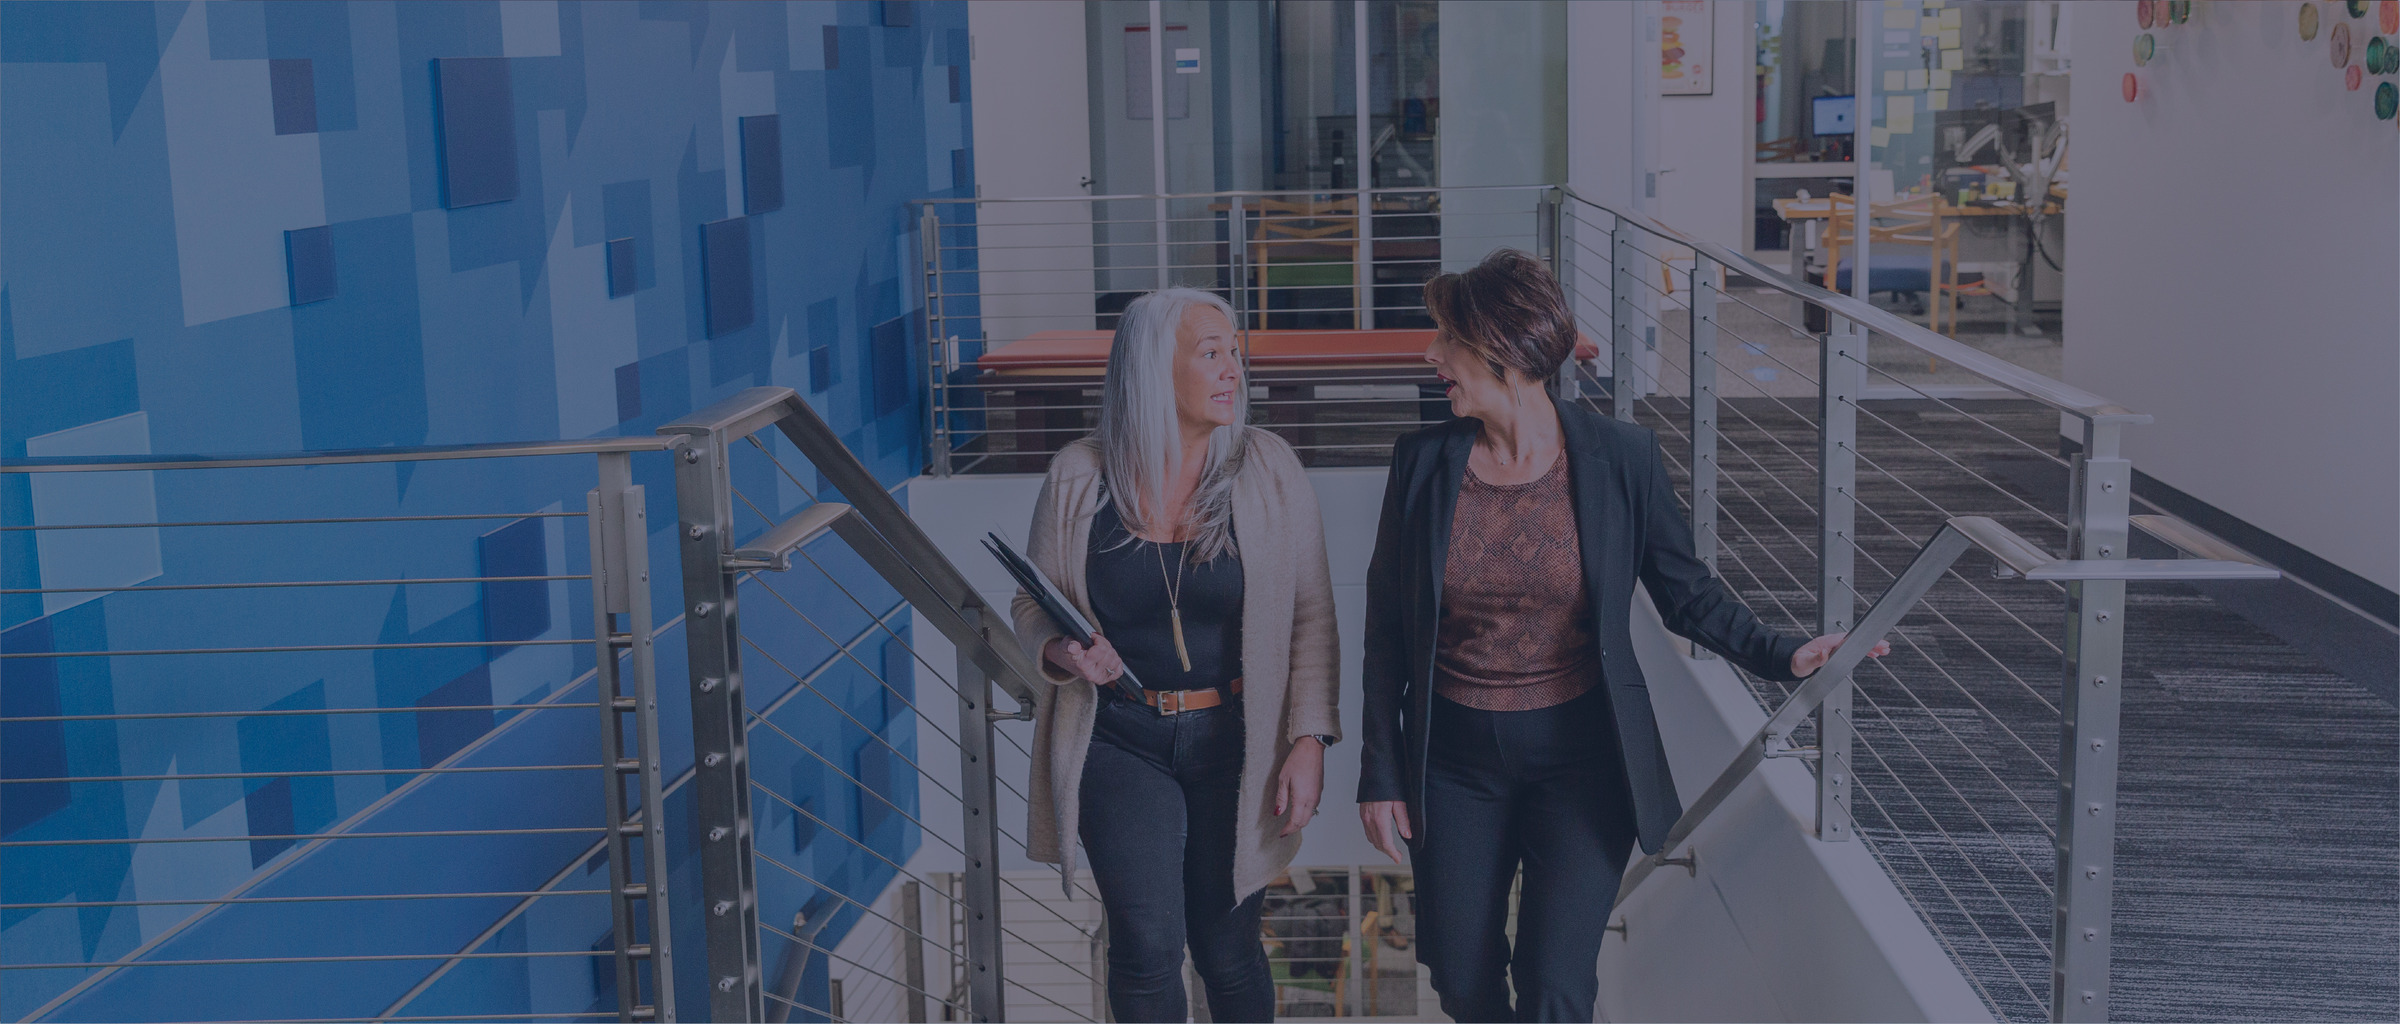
{"left": 1612, "top": 398, "right": 2400, "bottom": 1019}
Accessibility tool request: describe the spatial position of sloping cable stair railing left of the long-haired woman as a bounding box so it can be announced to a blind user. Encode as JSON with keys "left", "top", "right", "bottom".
{"left": 660, "top": 388, "right": 1099, "bottom": 1019}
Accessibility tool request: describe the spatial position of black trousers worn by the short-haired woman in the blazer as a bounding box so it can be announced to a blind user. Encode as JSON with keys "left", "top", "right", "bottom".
{"left": 1411, "top": 686, "right": 1634, "bottom": 1022}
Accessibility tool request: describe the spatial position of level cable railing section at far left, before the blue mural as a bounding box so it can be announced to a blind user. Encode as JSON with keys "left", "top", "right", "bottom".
{"left": 0, "top": 439, "right": 674, "bottom": 1022}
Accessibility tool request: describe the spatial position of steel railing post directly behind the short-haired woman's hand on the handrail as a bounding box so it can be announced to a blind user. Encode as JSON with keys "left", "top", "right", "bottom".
{"left": 1817, "top": 321, "right": 1867, "bottom": 842}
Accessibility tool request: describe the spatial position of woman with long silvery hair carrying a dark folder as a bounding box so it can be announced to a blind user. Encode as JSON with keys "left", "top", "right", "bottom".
{"left": 1015, "top": 288, "right": 1342, "bottom": 1022}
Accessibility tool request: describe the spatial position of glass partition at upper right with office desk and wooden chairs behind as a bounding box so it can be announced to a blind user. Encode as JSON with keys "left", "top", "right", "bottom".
{"left": 1747, "top": 0, "right": 2073, "bottom": 384}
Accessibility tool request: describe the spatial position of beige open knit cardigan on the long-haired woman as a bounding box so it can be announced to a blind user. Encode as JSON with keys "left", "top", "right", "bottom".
{"left": 1013, "top": 427, "right": 1342, "bottom": 902}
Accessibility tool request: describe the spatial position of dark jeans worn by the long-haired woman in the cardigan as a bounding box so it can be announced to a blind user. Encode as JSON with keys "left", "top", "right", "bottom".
{"left": 1082, "top": 698, "right": 1274, "bottom": 1024}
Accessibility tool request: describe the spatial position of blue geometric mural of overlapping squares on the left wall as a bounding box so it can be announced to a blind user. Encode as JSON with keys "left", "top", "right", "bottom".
{"left": 0, "top": 0, "right": 972, "bottom": 1019}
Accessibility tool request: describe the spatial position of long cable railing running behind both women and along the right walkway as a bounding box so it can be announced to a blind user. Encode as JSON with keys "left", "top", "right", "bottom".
{"left": 897, "top": 187, "right": 2284, "bottom": 1019}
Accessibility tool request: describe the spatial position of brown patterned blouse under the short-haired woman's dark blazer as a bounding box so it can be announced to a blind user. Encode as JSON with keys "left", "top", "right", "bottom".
{"left": 1433, "top": 453, "right": 1601, "bottom": 712}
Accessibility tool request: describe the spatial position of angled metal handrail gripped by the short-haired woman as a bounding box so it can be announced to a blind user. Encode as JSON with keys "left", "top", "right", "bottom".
{"left": 1618, "top": 516, "right": 2282, "bottom": 904}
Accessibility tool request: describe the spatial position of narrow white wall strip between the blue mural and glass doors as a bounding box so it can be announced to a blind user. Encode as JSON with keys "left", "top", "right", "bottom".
{"left": 953, "top": 0, "right": 1092, "bottom": 343}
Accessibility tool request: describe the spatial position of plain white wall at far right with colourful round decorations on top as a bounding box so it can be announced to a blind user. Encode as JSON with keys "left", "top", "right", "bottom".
{"left": 2066, "top": 2, "right": 2400, "bottom": 588}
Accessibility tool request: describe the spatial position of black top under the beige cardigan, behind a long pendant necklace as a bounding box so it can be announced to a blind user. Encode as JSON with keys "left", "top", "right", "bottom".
{"left": 1085, "top": 499, "right": 1241, "bottom": 691}
